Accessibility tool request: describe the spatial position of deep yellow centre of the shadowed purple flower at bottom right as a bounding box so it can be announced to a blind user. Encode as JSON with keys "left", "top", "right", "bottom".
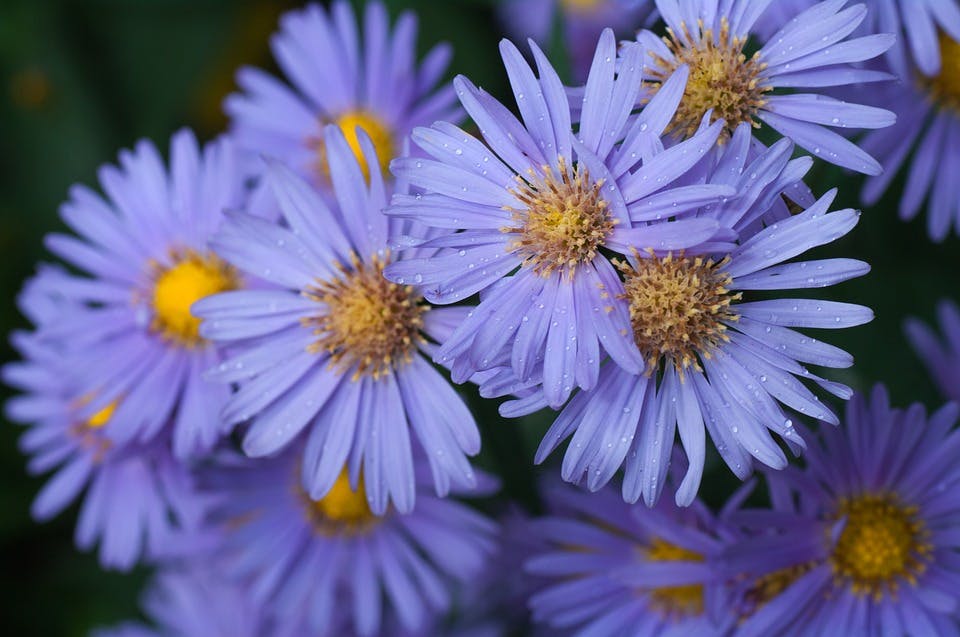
{"left": 830, "top": 494, "right": 932, "bottom": 598}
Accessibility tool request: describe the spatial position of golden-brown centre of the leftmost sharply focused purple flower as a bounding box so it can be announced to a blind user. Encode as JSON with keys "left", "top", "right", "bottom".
{"left": 304, "top": 255, "right": 428, "bottom": 380}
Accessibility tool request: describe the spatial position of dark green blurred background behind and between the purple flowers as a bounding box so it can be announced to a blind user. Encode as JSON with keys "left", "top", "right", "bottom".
{"left": 0, "top": 0, "right": 960, "bottom": 635}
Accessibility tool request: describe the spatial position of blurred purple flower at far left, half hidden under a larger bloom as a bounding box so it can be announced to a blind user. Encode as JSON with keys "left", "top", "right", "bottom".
{"left": 3, "top": 296, "right": 204, "bottom": 570}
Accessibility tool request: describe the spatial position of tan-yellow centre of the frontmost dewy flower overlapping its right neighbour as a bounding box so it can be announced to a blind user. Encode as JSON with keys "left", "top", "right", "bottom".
{"left": 502, "top": 158, "right": 615, "bottom": 276}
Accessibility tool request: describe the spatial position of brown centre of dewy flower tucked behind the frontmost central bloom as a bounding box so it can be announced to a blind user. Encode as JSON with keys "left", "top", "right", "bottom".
{"left": 615, "top": 250, "right": 740, "bottom": 373}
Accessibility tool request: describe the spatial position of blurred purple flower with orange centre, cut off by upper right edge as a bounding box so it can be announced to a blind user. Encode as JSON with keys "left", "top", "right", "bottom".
{"left": 861, "top": 31, "right": 960, "bottom": 241}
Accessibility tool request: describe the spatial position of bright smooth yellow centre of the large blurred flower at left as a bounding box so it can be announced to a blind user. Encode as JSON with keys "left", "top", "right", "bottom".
{"left": 150, "top": 250, "right": 240, "bottom": 347}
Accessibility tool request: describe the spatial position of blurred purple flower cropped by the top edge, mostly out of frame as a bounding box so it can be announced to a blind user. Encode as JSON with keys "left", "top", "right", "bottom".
{"left": 497, "top": 0, "right": 656, "bottom": 81}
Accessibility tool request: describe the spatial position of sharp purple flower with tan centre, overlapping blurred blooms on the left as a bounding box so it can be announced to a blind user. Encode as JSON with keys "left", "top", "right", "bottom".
{"left": 196, "top": 126, "right": 480, "bottom": 514}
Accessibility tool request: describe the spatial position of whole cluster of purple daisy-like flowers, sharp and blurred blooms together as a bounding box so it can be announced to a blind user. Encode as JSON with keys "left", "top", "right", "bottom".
{"left": 3, "top": 0, "right": 960, "bottom": 636}
